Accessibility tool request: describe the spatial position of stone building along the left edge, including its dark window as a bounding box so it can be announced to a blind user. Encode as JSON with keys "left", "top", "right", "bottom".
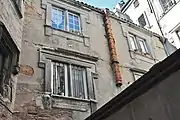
{"left": 0, "top": 0, "right": 23, "bottom": 120}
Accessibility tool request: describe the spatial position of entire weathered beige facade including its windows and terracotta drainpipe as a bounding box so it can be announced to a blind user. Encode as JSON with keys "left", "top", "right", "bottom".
{"left": 3, "top": 0, "right": 166, "bottom": 120}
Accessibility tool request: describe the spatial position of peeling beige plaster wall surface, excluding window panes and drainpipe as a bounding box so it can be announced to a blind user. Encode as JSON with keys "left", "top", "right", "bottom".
{"left": 13, "top": 0, "right": 166, "bottom": 120}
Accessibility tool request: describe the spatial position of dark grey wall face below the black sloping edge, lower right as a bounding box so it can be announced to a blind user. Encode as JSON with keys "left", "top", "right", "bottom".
{"left": 103, "top": 54, "right": 180, "bottom": 120}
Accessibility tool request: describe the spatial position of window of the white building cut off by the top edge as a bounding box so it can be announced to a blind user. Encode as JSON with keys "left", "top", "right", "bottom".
{"left": 159, "top": 0, "right": 174, "bottom": 12}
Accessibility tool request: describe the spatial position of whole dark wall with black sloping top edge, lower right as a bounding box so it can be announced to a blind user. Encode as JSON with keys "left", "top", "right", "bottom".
{"left": 86, "top": 50, "right": 180, "bottom": 120}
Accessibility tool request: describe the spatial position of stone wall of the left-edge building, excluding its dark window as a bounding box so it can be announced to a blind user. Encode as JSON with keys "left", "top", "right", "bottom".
{"left": 0, "top": 0, "right": 23, "bottom": 120}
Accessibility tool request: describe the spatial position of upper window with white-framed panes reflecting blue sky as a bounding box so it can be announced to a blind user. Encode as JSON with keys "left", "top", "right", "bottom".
{"left": 51, "top": 7, "right": 81, "bottom": 33}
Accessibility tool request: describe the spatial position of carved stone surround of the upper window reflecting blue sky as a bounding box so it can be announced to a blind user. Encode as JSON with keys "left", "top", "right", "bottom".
{"left": 41, "top": 0, "right": 90, "bottom": 47}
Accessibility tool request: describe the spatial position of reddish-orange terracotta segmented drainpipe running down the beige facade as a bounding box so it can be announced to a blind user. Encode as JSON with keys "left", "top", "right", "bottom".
{"left": 104, "top": 9, "right": 122, "bottom": 87}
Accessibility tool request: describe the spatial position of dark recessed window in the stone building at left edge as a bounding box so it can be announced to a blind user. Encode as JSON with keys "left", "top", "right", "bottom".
{"left": 0, "top": 22, "right": 19, "bottom": 100}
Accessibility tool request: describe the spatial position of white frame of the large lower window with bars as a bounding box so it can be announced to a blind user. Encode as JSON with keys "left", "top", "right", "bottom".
{"left": 51, "top": 61, "right": 88, "bottom": 100}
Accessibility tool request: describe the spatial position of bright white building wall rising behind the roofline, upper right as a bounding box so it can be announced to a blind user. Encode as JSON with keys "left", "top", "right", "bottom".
{"left": 114, "top": 0, "right": 180, "bottom": 48}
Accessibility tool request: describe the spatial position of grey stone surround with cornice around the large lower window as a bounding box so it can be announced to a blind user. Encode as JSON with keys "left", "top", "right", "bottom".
{"left": 38, "top": 49, "right": 98, "bottom": 112}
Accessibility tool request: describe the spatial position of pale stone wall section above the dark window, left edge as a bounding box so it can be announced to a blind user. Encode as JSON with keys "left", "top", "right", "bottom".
{"left": 0, "top": 0, "right": 23, "bottom": 50}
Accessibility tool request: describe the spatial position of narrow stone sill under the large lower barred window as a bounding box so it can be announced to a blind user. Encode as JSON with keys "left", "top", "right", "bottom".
{"left": 52, "top": 95, "right": 97, "bottom": 103}
